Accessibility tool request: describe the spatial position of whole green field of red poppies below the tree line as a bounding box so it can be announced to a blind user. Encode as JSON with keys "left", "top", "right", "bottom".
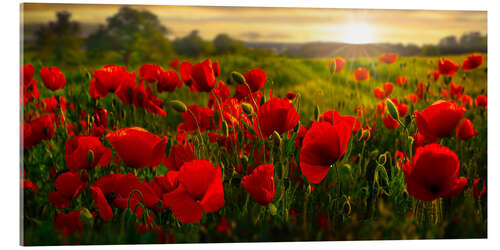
{"left": 20, "top": 53, "right": 487, "bottom": 245}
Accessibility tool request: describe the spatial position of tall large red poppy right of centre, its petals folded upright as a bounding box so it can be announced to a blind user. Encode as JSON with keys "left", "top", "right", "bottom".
{"left": 300, "top": 122, "right": 352, "bottom": 184}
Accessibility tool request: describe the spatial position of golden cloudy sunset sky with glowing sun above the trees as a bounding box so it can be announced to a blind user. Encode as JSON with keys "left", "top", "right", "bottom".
{"left": 21, "top": 4, "right": 487, "bottom": 45}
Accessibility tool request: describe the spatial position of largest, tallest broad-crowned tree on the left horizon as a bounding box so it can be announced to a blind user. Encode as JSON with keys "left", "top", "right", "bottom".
{"left": 86, "top": 6, "right": 172, "bottom": 66}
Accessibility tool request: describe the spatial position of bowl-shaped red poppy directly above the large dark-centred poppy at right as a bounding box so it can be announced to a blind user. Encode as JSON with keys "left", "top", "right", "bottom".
{"left": 415, "top": 101, "right": 466, "bottom": 138}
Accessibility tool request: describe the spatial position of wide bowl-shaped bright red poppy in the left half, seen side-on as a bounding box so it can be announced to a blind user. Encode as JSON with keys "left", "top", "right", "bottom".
{"left": 106, "top": 127, "right": 168, "bottom": 168}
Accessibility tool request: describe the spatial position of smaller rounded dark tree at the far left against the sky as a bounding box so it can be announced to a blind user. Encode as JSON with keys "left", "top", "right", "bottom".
{"left": 35, "top": 11, "right": 83, "bottom": 64}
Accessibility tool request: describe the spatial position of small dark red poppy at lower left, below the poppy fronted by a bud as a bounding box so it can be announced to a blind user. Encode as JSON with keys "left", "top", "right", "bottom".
{"left": 49, "top": 172, "right": 88, "bottom": 208}
